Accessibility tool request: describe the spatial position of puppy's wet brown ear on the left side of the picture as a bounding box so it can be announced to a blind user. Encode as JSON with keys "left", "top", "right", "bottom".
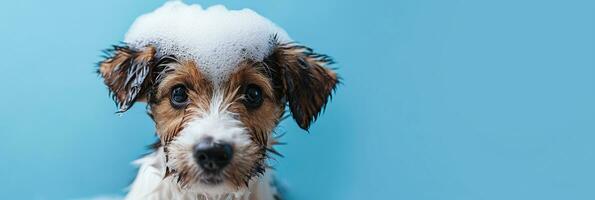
{"left": 98, "top": 46, "right": 155, "bottom": 113}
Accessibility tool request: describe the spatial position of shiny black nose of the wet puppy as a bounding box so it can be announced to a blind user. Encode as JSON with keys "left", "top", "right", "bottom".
{"left": 194, "top": 139, "right": 233, "bottom": 172}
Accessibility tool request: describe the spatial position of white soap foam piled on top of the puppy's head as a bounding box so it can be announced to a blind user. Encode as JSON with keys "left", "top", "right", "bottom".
{"left": 124, "top": 1, "right": 291, "bottom": 84}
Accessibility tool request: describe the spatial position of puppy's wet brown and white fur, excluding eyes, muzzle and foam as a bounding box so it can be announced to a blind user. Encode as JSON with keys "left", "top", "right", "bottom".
{"left": 98, "top": 37, "right": 339, "bottom": 199}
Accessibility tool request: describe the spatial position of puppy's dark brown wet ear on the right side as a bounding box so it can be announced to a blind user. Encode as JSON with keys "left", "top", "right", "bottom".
{"left": 271, "top": 43, "right": 339, "bottom": 130}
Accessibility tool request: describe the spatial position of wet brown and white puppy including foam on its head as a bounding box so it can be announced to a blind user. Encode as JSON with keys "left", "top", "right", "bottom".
{"left": 98, "top": 1, "right": 340, "bottom": 200}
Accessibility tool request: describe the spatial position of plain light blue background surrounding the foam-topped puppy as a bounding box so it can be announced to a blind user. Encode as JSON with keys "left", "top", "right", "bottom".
{"left": 0, "top": 0, "right": 595, "bottom": 200}
